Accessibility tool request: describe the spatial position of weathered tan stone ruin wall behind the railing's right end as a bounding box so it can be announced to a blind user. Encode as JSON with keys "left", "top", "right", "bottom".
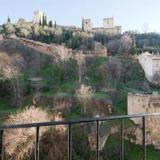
{"left": 128, "top": 93, "right": 160, "bottom": 149}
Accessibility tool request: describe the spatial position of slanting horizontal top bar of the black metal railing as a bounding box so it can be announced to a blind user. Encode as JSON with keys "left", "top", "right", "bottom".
{"left": 0, "top": 113, "right": 160, "bottom": 130}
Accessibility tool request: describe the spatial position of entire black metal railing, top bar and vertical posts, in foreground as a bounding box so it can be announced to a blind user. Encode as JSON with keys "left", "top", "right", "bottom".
{"left": 0, "top": 113, "right": 160, "bottom": 160}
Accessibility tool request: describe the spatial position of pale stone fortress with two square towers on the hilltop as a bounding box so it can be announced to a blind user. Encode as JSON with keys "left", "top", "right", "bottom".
{"left": 82, "top": 17, "right": 121, "bottom": 35}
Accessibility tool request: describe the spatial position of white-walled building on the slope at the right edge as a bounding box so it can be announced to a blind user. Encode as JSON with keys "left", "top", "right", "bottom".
{"left": 138, "top": 52, "right": 160, "bottom": 81}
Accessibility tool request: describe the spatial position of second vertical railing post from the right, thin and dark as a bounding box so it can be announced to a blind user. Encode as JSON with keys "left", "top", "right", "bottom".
{"left": 120, "top": 119, "right": 124, "bottom": 160}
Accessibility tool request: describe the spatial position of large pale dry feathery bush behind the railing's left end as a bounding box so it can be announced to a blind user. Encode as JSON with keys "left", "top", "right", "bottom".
{"left": 4, "top": 106, "right": 50, "bottom": 160}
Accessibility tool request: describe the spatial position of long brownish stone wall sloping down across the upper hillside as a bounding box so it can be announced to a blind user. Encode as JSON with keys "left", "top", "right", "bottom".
{"left": 4, "top": 36, "right": 107, "bottom": 57}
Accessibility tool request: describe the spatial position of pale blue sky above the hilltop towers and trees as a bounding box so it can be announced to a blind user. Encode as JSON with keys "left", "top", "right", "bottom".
{"left": 0, "top": 0, "right": 160, "bottom": 33}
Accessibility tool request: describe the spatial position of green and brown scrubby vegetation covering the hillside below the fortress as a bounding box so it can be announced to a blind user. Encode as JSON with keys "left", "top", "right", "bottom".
{"left": 0, "top": 25, "right": 159, "bottom": 160}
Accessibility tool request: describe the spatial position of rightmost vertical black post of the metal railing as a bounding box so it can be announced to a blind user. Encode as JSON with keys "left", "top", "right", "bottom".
{"left": 142, "top": 116, "right": 146, "bottom": 160}
